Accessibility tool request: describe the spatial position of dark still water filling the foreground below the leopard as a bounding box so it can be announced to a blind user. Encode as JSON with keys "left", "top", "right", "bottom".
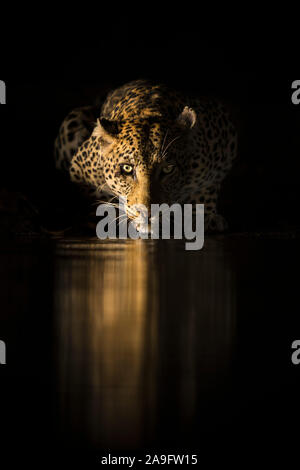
{"left": 0, "top": 236, "right": 300, "bottom": 463}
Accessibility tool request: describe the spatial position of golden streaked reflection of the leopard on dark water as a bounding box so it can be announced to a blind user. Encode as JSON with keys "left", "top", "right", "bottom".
{"left": 55, "top": 240, "right": 235, "bottom": 449}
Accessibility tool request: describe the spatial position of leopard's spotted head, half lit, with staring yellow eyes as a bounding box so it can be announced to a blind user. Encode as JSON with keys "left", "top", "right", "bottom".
{"left": 93, "top": 107, "right": 196, "bottom": 224}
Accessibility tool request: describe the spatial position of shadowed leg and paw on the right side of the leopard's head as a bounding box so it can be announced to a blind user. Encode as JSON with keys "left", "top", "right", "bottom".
{"left": 185, "top": 184, "right": 228, "bottom": 232}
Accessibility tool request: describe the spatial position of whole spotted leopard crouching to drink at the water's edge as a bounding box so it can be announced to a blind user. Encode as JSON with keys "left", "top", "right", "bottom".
{"left": 54, "top": 80, "right": 238, "bottom": 232}
